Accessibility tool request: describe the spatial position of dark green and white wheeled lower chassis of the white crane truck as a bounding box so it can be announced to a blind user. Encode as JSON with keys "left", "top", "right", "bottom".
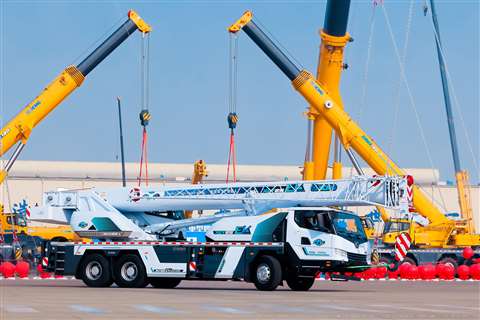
{"left": 45, "top": 241, "right": 366, "bottom": 291}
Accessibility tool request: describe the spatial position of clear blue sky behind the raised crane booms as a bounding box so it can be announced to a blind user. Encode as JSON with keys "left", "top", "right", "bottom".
{"left": 0, "top": 0, "right": 480, "bottom": 182}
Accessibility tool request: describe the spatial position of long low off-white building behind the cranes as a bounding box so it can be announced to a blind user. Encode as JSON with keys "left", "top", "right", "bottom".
{"left": 0, "top": 161, "right": 480, "bottom": 231}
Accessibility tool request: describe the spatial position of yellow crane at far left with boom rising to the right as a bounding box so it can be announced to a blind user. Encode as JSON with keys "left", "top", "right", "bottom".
{"left": 0, "top": 10, "right": 151, "bottom": 245}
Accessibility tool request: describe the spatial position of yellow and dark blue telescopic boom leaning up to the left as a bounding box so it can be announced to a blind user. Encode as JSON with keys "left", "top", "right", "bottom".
{"left": 229, "top": 12, "right": 452, "bottom": 225}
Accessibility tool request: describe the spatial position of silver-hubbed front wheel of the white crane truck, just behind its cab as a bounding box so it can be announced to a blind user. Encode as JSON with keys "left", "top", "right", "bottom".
{"left": 253, "top": 256, "right": 282, "bottom": 291}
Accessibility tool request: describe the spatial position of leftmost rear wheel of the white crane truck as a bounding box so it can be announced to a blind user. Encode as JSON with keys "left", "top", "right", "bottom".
{"left": 80, "top": 253, "right": 113, "bottom": 287}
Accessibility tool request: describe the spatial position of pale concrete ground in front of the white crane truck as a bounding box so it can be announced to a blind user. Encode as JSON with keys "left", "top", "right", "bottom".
{"left": 0, "top": 280, "right": 480, "bottom": 319}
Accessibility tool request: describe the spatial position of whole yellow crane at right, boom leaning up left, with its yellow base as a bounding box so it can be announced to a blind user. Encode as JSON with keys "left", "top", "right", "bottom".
{"left": 228, "top": 11, "right": 480, "bottom": 260}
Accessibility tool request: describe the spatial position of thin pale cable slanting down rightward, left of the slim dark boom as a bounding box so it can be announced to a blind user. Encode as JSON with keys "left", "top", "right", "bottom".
{"left": 382, "top": 5, "right": 446, "bottom": 210}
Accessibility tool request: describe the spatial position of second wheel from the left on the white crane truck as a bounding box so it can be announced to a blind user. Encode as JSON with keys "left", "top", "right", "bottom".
{"left": 113, "top": 254, "right": 148, "bottom": 288}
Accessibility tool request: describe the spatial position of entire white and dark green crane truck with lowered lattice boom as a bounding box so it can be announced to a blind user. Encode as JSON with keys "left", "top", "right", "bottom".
{"left": 35, "top": 177, "right": 408, "bottom": 290}
